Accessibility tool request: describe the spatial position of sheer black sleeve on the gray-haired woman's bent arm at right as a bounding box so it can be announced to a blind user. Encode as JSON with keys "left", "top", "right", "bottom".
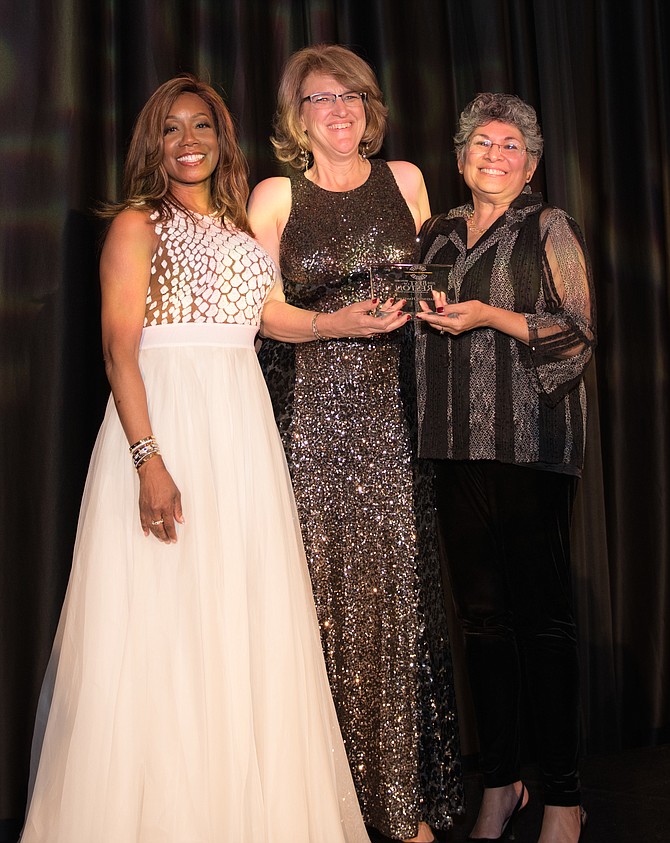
{"left": 526, "top": 208, "right": 596, "bottom": 405}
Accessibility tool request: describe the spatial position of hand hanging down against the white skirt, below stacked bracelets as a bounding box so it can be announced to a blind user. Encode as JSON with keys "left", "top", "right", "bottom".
{"left": 137, "top": 456, "right": 184, "bottom": 544}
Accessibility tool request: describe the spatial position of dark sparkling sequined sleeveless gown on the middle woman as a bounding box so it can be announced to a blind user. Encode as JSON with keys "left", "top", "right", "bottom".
{"left": 260, "top": 160, "right": 463, "bottom": 838}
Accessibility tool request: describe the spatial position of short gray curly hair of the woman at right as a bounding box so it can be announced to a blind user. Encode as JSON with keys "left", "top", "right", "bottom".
{"left": 454, "top": 93, "right": 544, "bottom": 164}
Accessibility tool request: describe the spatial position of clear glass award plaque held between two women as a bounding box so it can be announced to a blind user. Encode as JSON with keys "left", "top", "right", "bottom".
{"left": 369, "top": 263, "right": 452, "bottom": 314}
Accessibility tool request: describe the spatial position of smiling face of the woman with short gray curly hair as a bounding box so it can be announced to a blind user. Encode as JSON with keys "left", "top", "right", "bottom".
{"left": 461, "top": 120, "right": 536, "bottom": 205}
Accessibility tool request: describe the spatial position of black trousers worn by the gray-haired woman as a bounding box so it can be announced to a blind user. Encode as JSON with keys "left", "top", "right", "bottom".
{"left": 435, "top": 460, "right": 580, "bottom": 805}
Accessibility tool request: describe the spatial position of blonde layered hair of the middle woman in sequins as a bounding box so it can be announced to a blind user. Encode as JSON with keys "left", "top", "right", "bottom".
{"left": 271, "top": 44, "right": 388, "bottom": 170}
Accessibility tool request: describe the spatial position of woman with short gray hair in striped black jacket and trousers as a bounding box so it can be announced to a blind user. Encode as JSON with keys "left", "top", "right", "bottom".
{"left": 419, "top": 93, "right": 595, "bottom": 843}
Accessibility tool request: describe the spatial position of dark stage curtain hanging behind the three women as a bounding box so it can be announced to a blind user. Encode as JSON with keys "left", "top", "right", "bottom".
{"left": 0, "top": 0, "right": 670, "bottom": 839}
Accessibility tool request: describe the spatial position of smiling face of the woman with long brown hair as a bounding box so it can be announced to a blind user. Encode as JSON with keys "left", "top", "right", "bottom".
{"left": 163, "top": 93, "right": 219, "bottom": 193}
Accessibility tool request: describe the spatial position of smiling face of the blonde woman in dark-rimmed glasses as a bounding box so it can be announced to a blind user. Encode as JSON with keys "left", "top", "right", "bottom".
{"left": 300, "top": 73, "right": 366, "bottom": 160}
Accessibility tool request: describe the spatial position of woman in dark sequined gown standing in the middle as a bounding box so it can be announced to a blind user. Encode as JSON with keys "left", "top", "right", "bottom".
{"left": 249, "top": 45, "right": 462, "bottom": 841}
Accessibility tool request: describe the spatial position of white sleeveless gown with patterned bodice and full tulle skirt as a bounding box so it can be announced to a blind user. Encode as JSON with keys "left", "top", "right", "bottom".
{"left": 21, "top": 211, "right": 369, "bottom": 843}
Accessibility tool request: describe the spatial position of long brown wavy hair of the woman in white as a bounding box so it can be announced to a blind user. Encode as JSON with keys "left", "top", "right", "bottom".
{"left": 98, "top": 73, "right": 252, "bottom": 234}
